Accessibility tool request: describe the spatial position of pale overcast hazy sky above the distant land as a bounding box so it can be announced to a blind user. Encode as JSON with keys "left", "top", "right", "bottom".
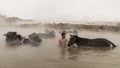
{"left": 0, "top": 0, "right": 120, "bottom": 22}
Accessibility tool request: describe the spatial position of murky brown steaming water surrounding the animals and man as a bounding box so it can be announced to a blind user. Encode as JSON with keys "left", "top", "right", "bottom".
{"left": 0, "top": 27, "right": 120, "bottom": 68}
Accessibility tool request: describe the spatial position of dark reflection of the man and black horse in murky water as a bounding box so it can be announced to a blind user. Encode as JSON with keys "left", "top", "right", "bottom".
{"left": 60, "top": 47, "right": 113, "bottom": 60}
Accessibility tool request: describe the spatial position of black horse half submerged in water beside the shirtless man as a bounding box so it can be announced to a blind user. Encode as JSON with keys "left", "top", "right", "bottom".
{"left": 68, "top": 35, "right": 116, "bottom": 48}
